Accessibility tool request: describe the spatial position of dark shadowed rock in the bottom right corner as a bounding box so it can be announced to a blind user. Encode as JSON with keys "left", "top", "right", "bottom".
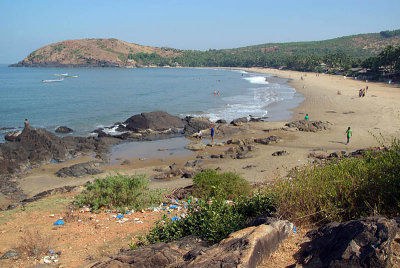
{"left": 300, "top": 216, "right": 398, "bottom": 267}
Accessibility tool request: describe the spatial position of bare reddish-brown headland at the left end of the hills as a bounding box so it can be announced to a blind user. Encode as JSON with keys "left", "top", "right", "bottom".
{"left": 11, "top": 39, "right": 180, "bottom": 67}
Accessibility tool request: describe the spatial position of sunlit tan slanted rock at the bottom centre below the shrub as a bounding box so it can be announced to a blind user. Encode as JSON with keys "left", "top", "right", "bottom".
{"left": 88, "top": 221, "right": 293, "bottom": 268}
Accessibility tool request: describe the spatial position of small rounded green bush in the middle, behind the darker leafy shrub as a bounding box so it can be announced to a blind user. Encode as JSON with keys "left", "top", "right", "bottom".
{"left": 193, "top": 169, "right": 251, "bottom": 200}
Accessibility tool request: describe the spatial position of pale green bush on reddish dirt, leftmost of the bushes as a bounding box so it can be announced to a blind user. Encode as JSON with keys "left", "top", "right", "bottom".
{"left": 75, "top": 174, "right": 163, "bottom": 211}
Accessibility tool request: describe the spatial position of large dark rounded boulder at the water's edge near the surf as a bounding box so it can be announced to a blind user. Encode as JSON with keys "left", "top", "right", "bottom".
{"left": 124, "top": 111, "right": 185, "bottom": 131}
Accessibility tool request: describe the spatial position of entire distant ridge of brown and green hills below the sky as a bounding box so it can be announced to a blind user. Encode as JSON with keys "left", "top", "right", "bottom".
{"left": 11, "top": 30, "right": 400, "bottom": 67}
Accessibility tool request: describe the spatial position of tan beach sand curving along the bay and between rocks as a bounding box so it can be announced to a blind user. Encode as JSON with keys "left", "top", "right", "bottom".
{"left": 0, "top": 68, "right": 400, "bottom": 208}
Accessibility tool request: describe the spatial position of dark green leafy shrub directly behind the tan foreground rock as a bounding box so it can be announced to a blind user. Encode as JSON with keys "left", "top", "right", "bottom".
{"left": 146, "top": 194, "right": 274, "bottom": 244}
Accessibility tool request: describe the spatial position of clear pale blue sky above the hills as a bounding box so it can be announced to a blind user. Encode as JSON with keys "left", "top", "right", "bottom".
{"left": 0, "top": 0, "right": 400, "bottom": 64}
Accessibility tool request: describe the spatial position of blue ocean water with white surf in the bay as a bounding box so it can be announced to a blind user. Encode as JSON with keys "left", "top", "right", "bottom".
{"left": 0, "top": 65, "right": 301, "bottom": 142}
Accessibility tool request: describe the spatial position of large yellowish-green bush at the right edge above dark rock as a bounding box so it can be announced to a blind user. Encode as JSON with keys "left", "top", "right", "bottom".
{"left": 271, "top": 140, "right": 400, "bottom": 224}
